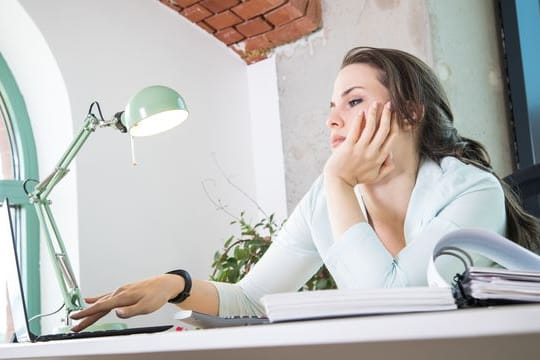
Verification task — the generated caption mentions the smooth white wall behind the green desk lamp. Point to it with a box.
[7,0,268,332]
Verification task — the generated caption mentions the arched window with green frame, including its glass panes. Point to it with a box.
[0,53,41,333]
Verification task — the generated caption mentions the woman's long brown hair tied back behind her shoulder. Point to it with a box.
[341,47,540,253]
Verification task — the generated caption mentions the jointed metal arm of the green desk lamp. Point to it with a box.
[28,114,122,325]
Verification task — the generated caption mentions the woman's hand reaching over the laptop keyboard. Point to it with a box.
[71,274,184,332]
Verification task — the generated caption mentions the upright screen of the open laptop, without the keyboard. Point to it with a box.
[0,198,32,342]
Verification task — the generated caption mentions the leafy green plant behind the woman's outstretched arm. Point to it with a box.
[210,212,336,290]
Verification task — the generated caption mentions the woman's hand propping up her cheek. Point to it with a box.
[324,102,399,187]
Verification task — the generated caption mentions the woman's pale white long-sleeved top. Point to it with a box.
[214,157,506,316]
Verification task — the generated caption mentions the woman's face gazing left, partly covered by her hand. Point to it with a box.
[326,64,390,149]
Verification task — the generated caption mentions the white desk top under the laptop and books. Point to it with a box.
[0,305,540,360]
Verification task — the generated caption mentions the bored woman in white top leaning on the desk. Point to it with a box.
[72,48,540,331]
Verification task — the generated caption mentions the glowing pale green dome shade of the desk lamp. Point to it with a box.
[122,85,188,136]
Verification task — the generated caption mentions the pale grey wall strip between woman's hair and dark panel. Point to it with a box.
[427,0,514,177]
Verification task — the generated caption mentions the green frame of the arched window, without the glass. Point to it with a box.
[0,53,41,334]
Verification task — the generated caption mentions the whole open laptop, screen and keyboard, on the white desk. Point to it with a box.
[0,198,173,342]
